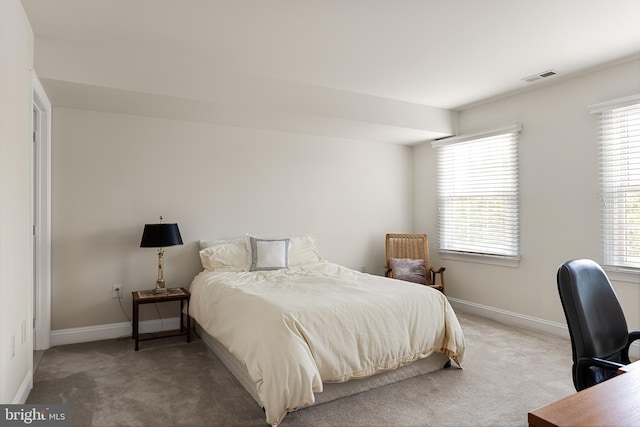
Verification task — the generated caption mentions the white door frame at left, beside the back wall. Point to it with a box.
[31,70,51,350]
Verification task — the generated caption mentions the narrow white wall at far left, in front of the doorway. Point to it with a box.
[0,0,33,403]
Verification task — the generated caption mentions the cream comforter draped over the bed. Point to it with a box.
[189,262,464,425]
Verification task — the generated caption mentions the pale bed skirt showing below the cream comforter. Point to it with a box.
[194,322,449,407]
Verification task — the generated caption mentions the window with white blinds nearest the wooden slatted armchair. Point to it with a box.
[432,125,521,260]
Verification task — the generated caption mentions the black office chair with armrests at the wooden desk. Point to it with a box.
[558,259,640,391]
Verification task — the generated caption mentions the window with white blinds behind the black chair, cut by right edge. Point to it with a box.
[591,96,640,268]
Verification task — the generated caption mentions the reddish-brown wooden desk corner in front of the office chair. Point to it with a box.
[528,365,640,427]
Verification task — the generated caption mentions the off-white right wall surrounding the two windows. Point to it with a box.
[414,59,640,328]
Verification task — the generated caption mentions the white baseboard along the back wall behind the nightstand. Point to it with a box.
[51,317,180,347]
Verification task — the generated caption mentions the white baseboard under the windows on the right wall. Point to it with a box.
[447,297,640,359]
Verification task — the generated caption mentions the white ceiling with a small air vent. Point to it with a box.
[17,0,640,144]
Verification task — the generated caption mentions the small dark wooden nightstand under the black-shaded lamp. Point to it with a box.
[131,288,191,351]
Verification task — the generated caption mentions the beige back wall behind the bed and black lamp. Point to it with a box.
[52,107,413,330]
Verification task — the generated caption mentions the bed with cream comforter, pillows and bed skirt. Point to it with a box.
[189,236,464,426]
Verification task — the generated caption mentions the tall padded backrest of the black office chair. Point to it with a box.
[558,259,629,370]
